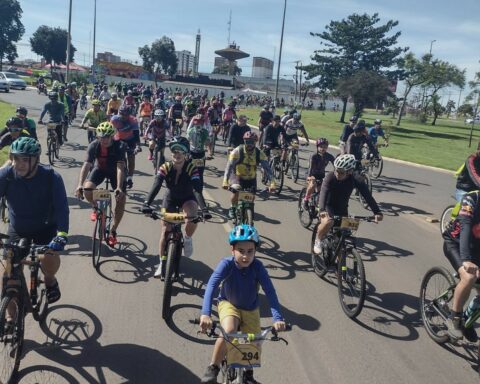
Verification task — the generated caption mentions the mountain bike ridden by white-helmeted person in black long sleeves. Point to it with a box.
[310,216,375,318]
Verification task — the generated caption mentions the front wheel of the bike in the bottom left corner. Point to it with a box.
[0,292,25,384]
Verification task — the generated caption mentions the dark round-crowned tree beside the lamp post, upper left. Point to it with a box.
[30,25,77,73]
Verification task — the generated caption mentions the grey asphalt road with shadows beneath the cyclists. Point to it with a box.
[0,90,478,384]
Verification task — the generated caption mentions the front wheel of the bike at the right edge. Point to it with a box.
[420,267,455,344]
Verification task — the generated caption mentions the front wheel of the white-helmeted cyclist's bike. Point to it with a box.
[337,247,367,319]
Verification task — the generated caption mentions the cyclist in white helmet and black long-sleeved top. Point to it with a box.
[313,154,383,253]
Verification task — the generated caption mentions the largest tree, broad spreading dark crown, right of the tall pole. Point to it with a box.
[303,13,408,122]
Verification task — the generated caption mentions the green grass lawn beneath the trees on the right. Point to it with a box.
[238,108,480,170]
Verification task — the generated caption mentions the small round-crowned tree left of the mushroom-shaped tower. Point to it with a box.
[138,36,178,85]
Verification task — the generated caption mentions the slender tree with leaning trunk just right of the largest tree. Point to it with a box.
[397,52,432,125]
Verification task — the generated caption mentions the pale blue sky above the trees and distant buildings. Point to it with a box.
[14,0,480,98]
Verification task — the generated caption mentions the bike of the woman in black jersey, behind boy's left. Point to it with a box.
[142,209,204,322]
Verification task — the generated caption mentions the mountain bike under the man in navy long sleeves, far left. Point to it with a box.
[0,235,49,383]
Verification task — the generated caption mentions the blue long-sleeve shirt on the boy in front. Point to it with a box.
[202,256,283,322]
